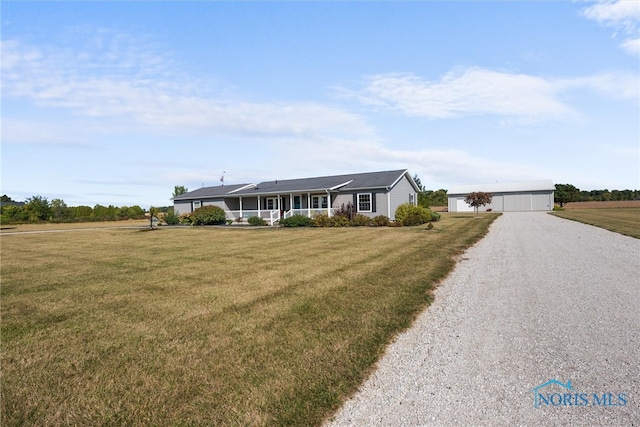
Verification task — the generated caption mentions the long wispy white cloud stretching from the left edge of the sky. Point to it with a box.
[2,38,372,142]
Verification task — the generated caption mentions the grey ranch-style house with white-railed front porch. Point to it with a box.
[173,170,419,225]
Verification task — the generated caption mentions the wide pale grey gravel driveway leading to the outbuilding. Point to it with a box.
[329,213,640,426]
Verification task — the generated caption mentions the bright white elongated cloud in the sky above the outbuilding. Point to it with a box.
[343,68,638,123]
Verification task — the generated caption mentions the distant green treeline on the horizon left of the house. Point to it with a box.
[0,195,168,224]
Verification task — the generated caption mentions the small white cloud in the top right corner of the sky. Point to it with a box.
[581,0,640,55]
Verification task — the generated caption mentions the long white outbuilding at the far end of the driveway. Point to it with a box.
[447,180,556,212]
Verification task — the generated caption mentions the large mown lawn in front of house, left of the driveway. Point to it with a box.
[0,214,496,426]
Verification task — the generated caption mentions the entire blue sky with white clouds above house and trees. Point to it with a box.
[1,0,640,208]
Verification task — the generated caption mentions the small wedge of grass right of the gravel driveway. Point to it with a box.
[552,208,640,239]
